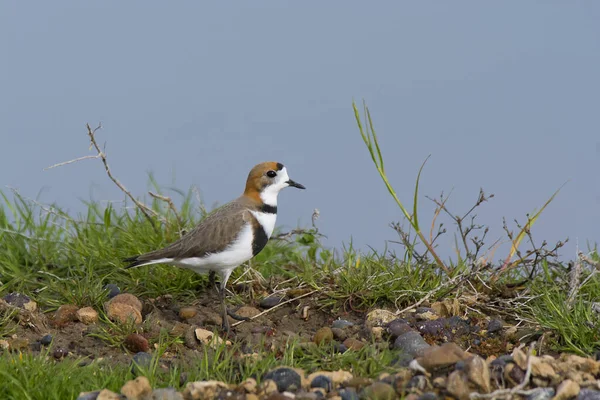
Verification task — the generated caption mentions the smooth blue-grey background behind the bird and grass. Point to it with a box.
[0,0,600,258]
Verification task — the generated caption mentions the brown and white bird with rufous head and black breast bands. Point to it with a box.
[123,161,306,334]
